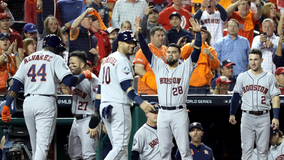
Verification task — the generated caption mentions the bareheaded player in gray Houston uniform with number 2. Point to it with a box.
[229,49,280,160]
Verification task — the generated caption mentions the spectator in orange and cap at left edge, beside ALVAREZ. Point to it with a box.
[0,33,21,94]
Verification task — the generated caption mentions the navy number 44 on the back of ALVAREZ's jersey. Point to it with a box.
[27,63,46,82]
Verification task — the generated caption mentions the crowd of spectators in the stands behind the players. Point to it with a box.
[0,0,284,157]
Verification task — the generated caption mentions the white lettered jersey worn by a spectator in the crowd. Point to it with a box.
[199,10,225,46]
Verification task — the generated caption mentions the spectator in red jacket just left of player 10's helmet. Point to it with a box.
[91,18,111,76]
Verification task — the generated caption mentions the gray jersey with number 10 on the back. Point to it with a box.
[99,51,134,105]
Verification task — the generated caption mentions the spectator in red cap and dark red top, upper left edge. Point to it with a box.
[0,12,23,57]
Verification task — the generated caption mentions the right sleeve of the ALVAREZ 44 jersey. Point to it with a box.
[54,56,72,81]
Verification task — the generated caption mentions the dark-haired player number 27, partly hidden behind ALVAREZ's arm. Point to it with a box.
[68,51,100,160]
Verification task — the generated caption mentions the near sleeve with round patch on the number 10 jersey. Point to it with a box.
[116,61,133,83]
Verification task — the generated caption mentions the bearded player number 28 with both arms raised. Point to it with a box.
[135,17,201,160]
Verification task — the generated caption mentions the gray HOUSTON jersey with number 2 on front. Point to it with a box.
[234,70,281,111]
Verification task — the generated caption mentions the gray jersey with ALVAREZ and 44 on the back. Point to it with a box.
[14,50,72,96]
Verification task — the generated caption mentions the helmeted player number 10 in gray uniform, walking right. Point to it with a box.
[89,30,154,160]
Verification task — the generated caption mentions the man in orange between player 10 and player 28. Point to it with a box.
[133,26,167,95]
